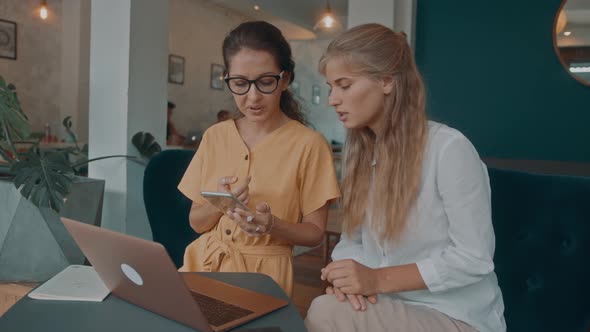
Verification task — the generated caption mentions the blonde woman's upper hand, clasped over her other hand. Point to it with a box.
[321,259,378,296]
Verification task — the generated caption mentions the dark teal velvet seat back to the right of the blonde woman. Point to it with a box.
[489,168,590,332]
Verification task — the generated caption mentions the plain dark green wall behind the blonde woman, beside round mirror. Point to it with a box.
[416,0,590,162]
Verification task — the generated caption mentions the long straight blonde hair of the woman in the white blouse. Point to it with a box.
[319,24,428,241]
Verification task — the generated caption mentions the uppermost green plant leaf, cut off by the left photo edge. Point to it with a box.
[0,76,31,141]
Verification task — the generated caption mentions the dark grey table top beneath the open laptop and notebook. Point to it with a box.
[0,272,305,332]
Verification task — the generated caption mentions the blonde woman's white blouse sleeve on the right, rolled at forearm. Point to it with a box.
[417,136,495,292]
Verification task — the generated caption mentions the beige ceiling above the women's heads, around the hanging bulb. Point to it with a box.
[208,0,348,40]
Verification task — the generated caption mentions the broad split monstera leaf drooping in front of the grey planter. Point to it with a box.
[11,150,73,212]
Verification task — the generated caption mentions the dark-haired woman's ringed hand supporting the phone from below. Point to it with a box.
[228,202,275,236]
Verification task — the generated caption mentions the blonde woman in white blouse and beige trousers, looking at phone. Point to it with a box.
[306,24,506,332]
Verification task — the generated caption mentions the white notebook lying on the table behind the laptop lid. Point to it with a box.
[28,265,110,302]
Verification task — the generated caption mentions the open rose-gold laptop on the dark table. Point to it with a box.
[61,218,288,331]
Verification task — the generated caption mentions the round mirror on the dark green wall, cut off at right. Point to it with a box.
[553,0,590,86]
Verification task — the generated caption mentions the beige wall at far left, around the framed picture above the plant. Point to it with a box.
[0,0,62,136]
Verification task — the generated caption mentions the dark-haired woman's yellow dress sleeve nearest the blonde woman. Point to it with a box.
[299,134,340,216]
